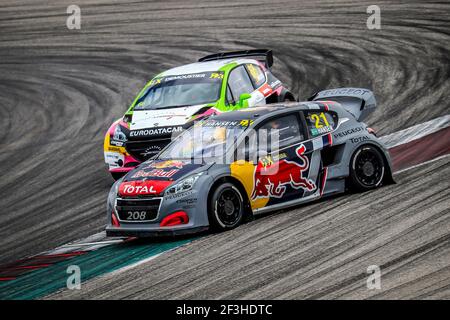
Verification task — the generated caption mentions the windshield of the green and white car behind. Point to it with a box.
[134,72,223,110]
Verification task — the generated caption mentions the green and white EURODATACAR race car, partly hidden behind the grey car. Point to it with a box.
[104,50,295,179]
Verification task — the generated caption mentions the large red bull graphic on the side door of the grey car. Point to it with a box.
[252,145,316,200]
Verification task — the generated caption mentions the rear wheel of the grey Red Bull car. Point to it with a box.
[349,145,386,192]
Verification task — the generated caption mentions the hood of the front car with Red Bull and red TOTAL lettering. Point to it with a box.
[119,160,204,197]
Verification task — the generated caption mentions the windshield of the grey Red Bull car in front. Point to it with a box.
[158,120,248,161]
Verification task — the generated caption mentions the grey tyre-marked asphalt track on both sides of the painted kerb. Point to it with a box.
[0,0,450,298]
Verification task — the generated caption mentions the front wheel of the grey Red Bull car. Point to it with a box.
[208,182,244,231]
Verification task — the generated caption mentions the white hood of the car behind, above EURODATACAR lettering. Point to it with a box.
[130,104,206,130]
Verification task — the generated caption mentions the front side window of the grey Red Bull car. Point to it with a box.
[258,114,305,150]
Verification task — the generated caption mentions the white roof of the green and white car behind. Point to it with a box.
[159,58,256,77]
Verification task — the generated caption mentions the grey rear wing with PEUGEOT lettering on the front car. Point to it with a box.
[308,88,377,120]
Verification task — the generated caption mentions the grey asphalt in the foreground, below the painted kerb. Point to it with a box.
[48,157,450,300]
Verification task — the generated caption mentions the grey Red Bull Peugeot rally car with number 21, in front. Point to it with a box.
[106,88,393,237]
